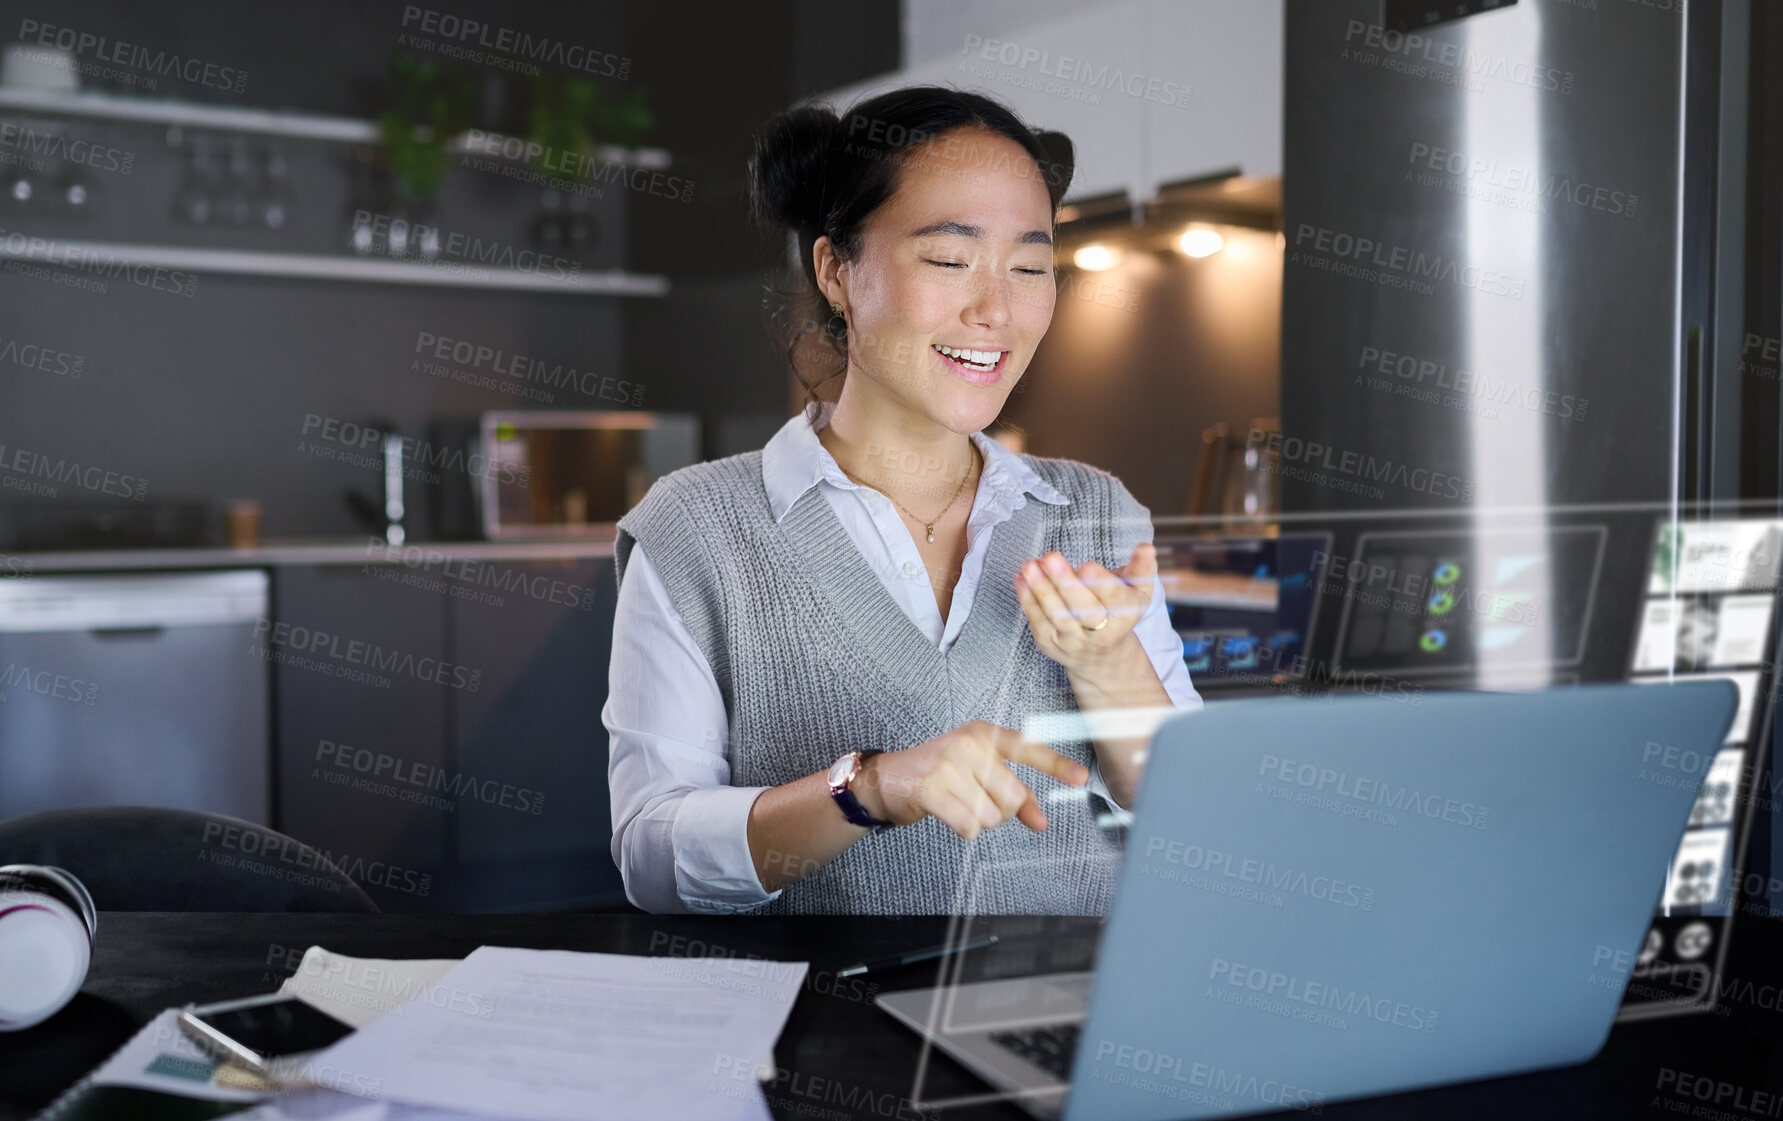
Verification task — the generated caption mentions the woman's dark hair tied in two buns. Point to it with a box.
[749,86,1075,415]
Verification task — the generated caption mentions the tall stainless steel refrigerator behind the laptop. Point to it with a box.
[1283,0,1778,1014]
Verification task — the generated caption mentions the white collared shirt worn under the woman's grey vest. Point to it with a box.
[601,403,1202,914]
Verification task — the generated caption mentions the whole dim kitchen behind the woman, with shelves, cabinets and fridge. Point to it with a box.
[0,0,1783,1005]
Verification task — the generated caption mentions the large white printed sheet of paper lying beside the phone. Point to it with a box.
[316,946,809,1121]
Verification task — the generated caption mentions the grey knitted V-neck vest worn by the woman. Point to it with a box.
[613,441,1152,914]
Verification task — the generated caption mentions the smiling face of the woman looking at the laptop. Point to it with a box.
[818,128,1057,433]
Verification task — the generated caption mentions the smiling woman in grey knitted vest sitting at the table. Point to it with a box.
[603,87,1200,914]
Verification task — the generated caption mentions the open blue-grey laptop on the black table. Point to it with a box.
[877,681,1737,1121]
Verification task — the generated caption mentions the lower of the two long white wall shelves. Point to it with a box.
[0,239,669,296]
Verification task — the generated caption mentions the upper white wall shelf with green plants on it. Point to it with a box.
[0,87,670,171]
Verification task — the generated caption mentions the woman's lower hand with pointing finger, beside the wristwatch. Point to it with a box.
[852,720,1089,841]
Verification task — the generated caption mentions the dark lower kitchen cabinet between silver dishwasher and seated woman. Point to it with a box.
[273,558,624,912]
